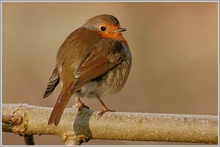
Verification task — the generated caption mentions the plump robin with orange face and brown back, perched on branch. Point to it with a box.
[43,14,132,126]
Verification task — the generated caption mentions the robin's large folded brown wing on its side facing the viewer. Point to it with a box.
[70,48,121,93]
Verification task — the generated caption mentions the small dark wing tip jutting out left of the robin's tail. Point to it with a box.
[43,66,59,98]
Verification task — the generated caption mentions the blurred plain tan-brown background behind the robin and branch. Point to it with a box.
[2,2,218,145]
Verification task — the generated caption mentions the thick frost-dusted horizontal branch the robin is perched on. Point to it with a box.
[2,104,218,145]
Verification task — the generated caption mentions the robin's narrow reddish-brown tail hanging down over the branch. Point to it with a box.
[48,90,71,125]
